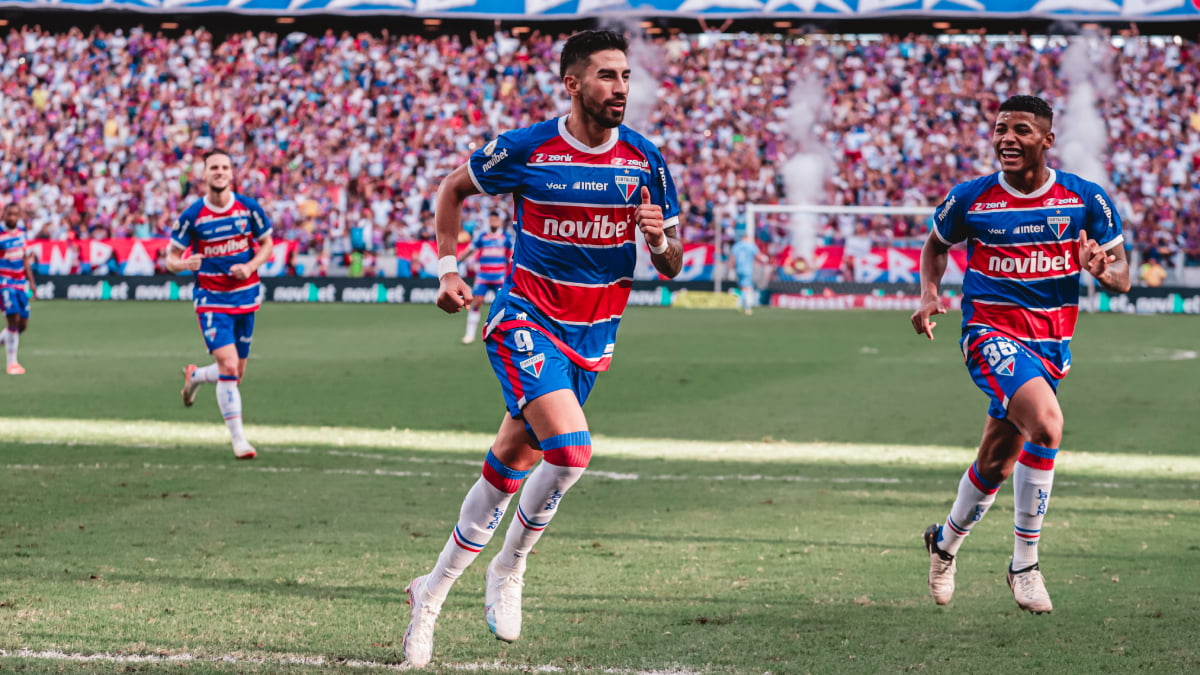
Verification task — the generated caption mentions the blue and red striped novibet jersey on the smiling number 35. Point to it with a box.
[934,171,1124,378]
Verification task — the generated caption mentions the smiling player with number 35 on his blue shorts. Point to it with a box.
[912,96,1129,614]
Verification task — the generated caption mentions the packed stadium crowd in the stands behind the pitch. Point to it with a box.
[0,26,1200,276]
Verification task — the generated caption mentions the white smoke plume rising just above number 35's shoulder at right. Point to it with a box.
[1055,30,1116,187]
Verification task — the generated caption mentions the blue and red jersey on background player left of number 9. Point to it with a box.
[170,193,271,313]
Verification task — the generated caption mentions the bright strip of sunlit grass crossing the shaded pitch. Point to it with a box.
[0,418,1200,480]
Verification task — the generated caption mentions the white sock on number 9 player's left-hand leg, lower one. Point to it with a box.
[425,477,512,604]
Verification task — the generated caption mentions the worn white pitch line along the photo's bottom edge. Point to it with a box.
[0,649,700,675]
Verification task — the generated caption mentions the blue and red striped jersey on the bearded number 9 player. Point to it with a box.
[468,117,679,371]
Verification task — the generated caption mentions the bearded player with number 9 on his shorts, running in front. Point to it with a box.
[404,30,683,667]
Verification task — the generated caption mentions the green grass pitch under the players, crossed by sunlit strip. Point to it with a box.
[0,300,1200,675]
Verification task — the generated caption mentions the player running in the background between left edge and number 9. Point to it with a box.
[167,149,271,459]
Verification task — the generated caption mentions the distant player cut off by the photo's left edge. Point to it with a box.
[0,203,37,375]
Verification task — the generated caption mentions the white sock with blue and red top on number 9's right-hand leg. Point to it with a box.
[494,431,592,571]
